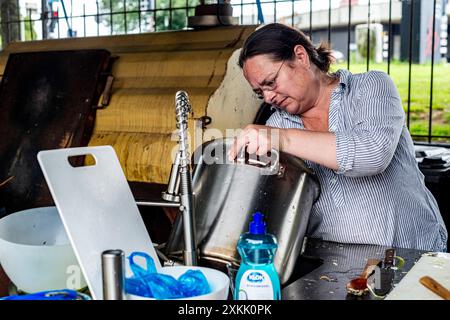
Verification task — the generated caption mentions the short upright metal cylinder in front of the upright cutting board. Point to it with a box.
[102,249,125,300]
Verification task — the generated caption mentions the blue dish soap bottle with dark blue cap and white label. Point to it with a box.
[234,212,281,300]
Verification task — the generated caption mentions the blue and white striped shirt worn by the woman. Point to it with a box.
[266,70,448,251]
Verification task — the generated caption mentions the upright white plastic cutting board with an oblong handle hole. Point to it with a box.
[37,146,161,299]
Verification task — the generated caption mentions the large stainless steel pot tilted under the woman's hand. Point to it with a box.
[166,139,320,284]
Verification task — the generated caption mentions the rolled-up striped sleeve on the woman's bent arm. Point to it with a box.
[335,72,405,177]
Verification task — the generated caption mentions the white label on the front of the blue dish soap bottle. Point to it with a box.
[238,269,274,300]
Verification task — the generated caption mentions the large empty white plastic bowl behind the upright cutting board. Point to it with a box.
[0,207,86,293]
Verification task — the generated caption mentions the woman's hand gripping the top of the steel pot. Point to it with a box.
[228,124,283,161]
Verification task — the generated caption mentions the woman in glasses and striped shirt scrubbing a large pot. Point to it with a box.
[229,24,447,251]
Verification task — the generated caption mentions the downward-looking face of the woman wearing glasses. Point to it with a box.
[243,47,320,114]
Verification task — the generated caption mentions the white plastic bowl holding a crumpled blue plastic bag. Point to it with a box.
[127,266,230,300]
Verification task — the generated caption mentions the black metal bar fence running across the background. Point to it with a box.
[1,0,450,144]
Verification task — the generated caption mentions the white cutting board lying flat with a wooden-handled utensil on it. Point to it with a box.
[386,252,450,300]
